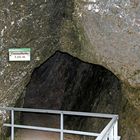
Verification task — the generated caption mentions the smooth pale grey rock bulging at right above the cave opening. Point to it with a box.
[77,0,140,88]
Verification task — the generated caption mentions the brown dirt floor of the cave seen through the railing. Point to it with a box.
[15,113,80,140]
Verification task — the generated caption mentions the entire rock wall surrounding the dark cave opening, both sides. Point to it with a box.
[0,0,140,140]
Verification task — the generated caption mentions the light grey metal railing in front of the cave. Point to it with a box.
[0,107,120,140]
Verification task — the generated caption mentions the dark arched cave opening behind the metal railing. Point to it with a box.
[15,52,121,140]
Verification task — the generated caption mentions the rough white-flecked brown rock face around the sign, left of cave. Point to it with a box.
[0,0,74,106]
